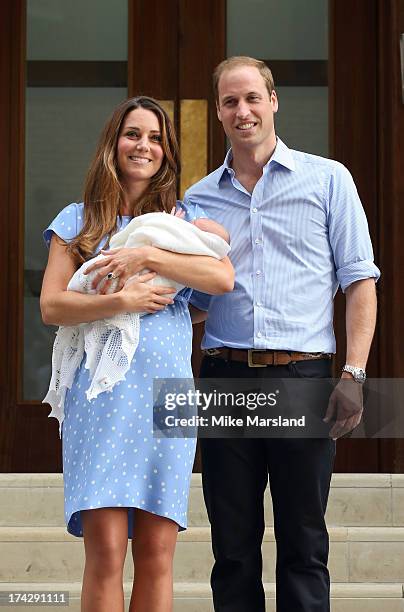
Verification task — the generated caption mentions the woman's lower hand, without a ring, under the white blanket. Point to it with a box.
[119,272,176,313]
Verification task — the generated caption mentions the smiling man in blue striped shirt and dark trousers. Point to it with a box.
[185,57,379,612]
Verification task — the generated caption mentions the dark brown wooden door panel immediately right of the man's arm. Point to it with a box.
[330,0,380,472]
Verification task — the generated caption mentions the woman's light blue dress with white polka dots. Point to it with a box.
[44,204,205,538]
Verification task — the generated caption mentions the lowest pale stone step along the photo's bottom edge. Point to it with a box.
[0,582,404,612]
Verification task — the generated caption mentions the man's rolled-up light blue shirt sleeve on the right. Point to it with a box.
[328,164,380,293]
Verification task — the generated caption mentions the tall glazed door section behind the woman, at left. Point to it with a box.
[23,0,127,400]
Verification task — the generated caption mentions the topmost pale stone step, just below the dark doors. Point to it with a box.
[0,474,404,527]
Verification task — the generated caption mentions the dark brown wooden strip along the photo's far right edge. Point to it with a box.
[377,0,404,472]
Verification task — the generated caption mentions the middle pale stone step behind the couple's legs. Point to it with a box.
[0,527,404,583]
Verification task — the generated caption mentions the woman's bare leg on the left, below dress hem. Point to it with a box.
[81,508,128,612]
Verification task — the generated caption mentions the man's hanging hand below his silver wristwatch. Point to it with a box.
[323,374,363,440]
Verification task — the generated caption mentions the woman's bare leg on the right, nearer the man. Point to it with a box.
[129,510,178,612]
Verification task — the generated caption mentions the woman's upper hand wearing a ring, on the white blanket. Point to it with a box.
[84,246,153,294]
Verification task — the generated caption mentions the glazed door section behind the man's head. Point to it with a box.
[227,0,328,156]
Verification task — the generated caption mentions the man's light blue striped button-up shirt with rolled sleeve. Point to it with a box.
[184,138,380,353]
